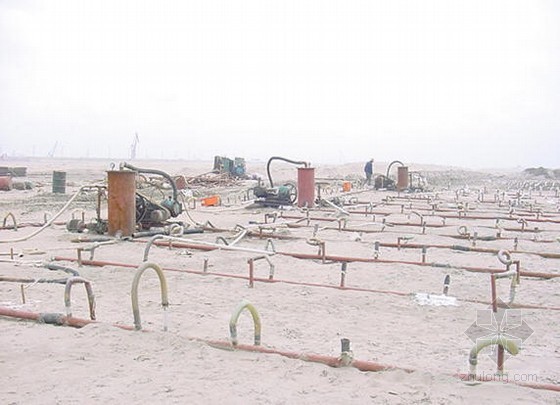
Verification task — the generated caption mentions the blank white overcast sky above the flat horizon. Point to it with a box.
[0,0,560,168]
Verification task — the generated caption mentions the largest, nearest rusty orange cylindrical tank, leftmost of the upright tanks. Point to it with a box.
[107,170,136,236]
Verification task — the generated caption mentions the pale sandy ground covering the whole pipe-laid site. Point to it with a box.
[0,159,560,404]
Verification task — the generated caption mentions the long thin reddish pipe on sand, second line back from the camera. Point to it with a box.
[53,257,560,311]
